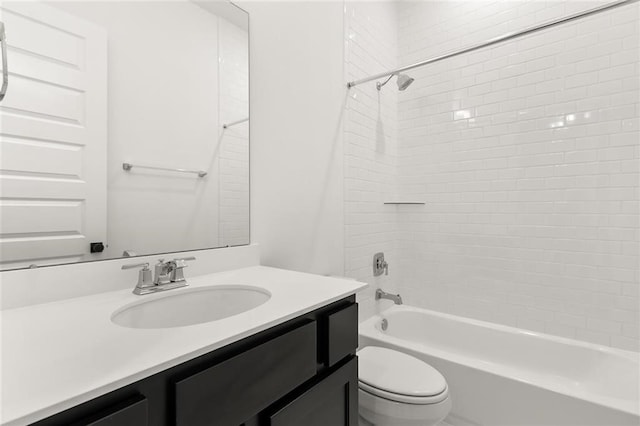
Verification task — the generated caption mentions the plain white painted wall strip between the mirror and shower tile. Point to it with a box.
[240,2,346,275]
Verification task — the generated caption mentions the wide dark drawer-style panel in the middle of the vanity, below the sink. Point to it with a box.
[175,320,317,426]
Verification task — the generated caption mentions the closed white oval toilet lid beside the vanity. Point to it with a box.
[358,346,447,396]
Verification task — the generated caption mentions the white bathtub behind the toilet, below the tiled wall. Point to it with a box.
[360,306,640,426]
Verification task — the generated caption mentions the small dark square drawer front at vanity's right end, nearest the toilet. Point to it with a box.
[325,303,358,366]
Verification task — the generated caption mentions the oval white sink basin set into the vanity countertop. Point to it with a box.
[111,285,271,328]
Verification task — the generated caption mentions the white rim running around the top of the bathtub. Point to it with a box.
[359,305,640,416]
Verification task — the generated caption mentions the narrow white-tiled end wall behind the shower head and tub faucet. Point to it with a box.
[344,2,399,319]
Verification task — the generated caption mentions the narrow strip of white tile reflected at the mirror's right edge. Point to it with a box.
[218,19,249,246]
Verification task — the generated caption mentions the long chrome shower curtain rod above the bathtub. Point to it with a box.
[347,0,640,89]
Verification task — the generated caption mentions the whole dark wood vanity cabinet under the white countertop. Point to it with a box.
[35,296,358,426]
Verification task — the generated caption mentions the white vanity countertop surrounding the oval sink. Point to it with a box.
[0,266,366,425]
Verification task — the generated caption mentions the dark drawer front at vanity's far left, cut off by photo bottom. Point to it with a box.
[67,395,148,426]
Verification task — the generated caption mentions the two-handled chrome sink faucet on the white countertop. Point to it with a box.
[122,256,196,295]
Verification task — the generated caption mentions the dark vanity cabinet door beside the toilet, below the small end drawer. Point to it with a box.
[268,357,358,426]
